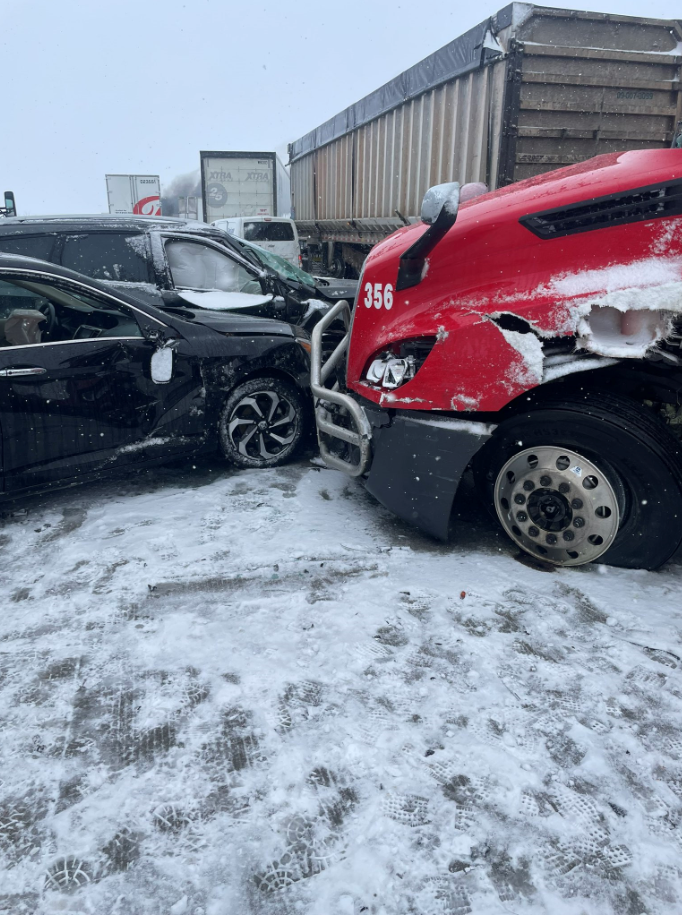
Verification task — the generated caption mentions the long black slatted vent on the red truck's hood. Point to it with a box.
[519,181,682,239]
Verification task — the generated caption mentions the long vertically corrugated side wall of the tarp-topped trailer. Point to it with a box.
[291,62,505,220]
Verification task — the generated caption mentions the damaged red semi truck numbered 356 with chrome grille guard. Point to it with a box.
[312,149,682,569]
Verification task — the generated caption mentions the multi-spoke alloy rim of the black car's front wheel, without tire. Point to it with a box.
[227,390,298,460]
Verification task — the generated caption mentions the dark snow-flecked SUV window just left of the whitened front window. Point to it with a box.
[62,232,149,283]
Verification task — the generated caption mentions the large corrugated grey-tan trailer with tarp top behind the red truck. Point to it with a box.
[289,3,682,276]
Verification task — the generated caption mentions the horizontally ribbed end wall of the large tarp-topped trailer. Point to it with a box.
[500,9,682,183]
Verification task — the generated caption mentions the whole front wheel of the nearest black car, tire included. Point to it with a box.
[218,377,305,467]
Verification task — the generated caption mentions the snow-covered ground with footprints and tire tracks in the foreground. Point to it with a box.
[0,452,682,915]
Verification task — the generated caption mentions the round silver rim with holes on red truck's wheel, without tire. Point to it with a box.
[494,446,620,566]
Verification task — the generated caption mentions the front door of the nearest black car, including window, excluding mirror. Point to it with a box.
[0,270,205,492]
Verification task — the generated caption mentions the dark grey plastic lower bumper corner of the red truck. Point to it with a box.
[365,416,495,540]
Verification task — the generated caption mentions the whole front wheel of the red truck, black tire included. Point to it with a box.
[474,392,682,569]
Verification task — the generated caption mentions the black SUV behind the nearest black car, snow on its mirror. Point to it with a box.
[0,215,338,329]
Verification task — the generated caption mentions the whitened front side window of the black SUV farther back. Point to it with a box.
[166,239,261,294]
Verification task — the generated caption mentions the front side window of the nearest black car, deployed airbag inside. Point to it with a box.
[0,280,142,348]
